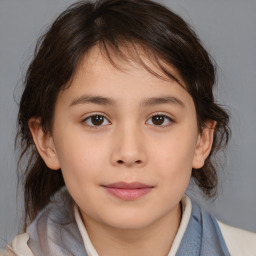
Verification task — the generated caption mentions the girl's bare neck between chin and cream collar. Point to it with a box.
[83,202,182,256]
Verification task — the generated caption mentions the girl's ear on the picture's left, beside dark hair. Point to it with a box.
[28,118,60,170]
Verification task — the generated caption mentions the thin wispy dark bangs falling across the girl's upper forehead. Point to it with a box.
[88,37,186,85]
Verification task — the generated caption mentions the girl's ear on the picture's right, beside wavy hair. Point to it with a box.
[192,120,216,169]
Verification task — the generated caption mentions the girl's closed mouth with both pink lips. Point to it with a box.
[102,182,154,201]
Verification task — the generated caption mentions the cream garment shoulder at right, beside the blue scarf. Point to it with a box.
[217,220,256,256]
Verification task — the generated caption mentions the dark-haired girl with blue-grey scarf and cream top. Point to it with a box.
[2,0,256,256]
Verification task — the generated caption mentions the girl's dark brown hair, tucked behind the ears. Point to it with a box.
[17,0,230,227]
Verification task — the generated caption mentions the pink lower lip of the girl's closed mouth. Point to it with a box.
[104,187,153,201]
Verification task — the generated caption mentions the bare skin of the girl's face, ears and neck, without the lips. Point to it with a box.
[29,48,215,256]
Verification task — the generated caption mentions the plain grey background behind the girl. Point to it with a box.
[0,0,256,247]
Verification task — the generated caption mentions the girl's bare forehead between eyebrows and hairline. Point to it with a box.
[58,47,192,110]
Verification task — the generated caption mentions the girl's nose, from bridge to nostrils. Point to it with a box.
[111,124,147,168]
